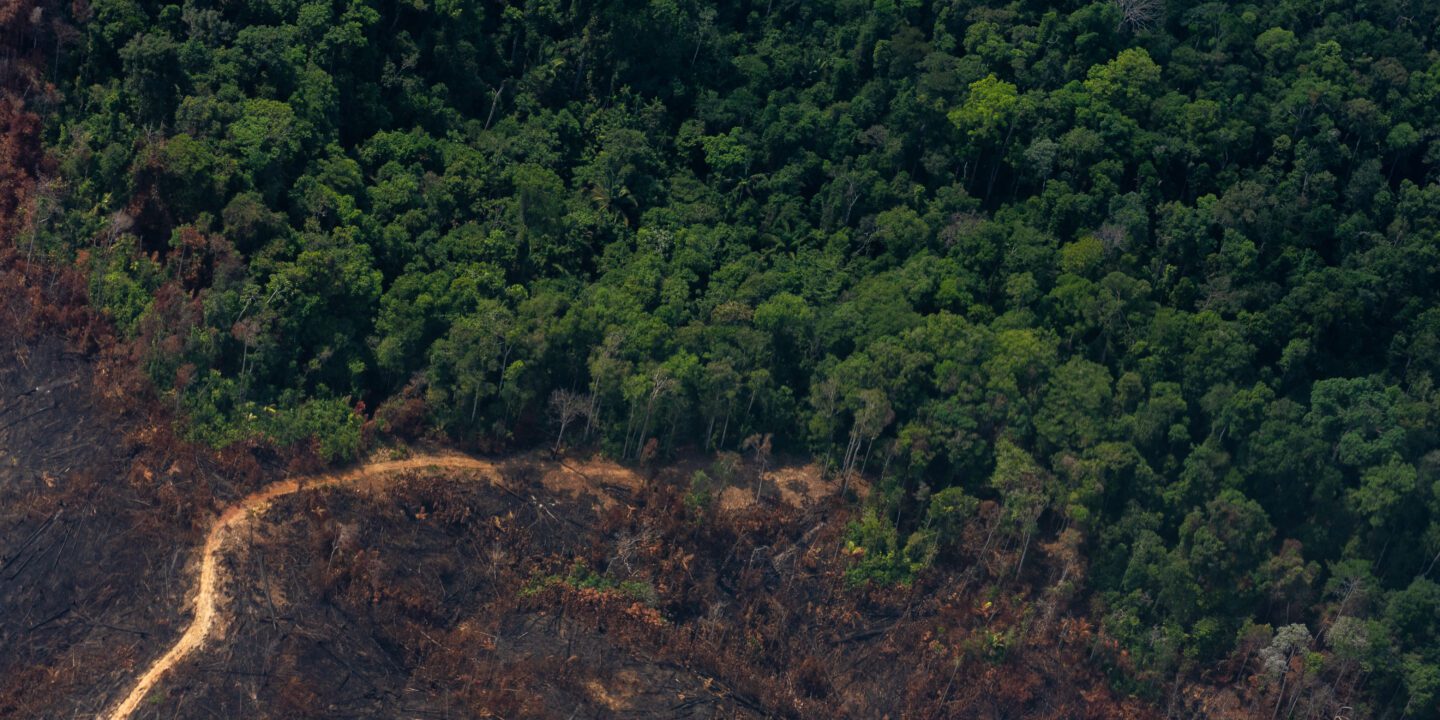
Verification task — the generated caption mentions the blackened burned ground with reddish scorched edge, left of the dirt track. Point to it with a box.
[0,256,266,719]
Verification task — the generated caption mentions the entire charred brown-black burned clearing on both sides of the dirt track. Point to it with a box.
[0,264,1155,719]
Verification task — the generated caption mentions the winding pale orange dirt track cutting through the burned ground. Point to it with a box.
[104,454,500,720]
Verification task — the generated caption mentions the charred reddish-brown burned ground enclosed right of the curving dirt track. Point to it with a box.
[90,458,1146,719]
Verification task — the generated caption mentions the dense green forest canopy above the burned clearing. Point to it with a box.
[16,0,1440,719]
